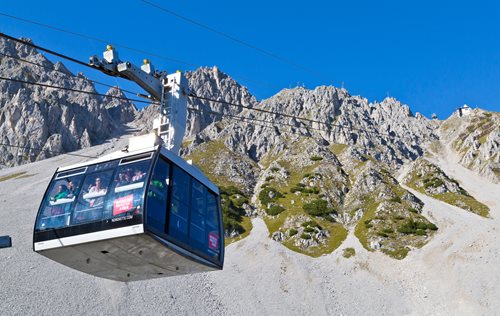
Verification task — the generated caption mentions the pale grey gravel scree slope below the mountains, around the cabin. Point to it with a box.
[0,141,500,315]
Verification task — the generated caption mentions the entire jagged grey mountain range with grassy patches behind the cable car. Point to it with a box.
[0,35,500,259]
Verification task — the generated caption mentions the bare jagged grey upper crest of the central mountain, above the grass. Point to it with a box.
[191,82,437,166]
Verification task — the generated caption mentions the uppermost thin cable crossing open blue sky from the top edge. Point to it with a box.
[140,0,324,76]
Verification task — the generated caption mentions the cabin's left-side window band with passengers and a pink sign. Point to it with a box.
[35,155,151,230]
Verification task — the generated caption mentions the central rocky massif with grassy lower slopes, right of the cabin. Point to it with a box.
[185,87,438,258]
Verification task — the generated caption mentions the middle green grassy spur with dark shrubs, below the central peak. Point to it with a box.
[257,156,347,257]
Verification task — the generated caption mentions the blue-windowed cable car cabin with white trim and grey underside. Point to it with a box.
[33,134,224,281]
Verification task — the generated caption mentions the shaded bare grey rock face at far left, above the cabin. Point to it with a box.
[0,38,119,166]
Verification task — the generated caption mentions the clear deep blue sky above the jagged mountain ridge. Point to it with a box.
[0,0,500,118]
